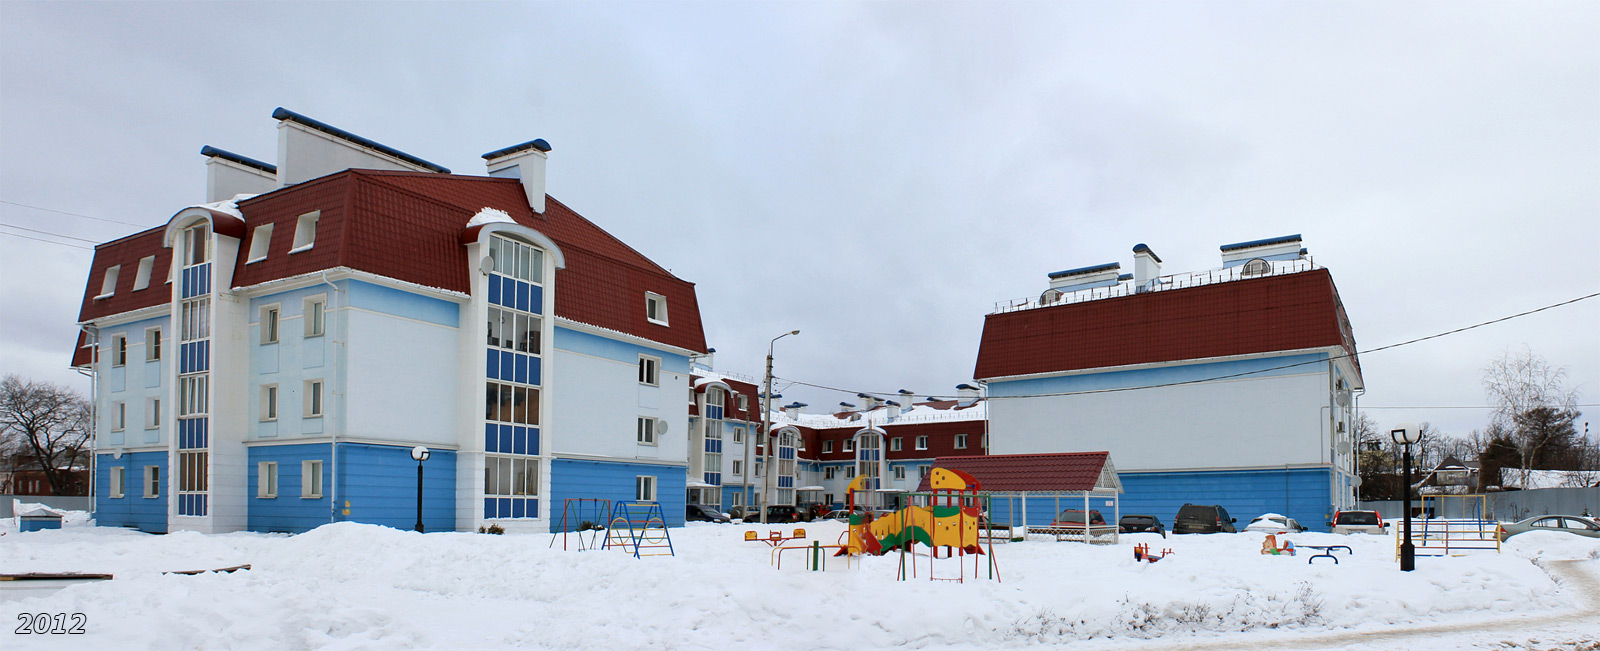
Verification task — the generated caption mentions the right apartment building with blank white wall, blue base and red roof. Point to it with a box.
[974,235,1363,526]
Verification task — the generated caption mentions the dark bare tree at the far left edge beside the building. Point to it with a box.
[0,374,93,494]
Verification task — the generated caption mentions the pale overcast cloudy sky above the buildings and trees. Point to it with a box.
[0,2,1600,433]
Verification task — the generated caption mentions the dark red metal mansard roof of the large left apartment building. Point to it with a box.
[80,170,706,352]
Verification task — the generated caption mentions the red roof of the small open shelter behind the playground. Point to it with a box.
[917,453,1110,493]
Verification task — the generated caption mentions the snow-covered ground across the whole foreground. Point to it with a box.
[0,523,1600,649]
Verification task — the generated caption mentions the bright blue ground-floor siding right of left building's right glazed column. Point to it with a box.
[550,459,688,531]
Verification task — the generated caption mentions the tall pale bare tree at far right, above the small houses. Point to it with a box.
[1483,347,1578,485]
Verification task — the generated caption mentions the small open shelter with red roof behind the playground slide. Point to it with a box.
[917,453,1123,542]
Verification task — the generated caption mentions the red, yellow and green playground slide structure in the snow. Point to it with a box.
[834,469,998,582]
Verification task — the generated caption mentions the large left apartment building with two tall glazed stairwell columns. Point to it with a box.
[74,109,706,533]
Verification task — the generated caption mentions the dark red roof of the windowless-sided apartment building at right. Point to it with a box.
[973,269,1355,379]
